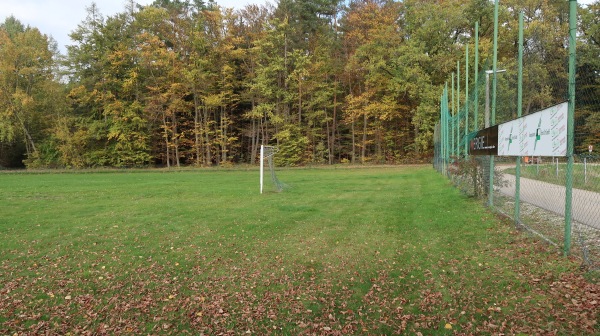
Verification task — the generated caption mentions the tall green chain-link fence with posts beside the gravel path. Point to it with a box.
[434,2,600,269]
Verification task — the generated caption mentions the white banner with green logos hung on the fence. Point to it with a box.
[498,102,568,156]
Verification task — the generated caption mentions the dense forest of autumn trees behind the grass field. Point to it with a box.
[0,0,600,168]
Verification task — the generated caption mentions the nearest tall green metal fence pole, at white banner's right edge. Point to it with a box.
[565,0,577,255]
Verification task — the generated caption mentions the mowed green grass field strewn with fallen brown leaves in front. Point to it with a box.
[0,166,600,335]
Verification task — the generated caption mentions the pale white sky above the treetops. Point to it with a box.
[0,0,271,53]
